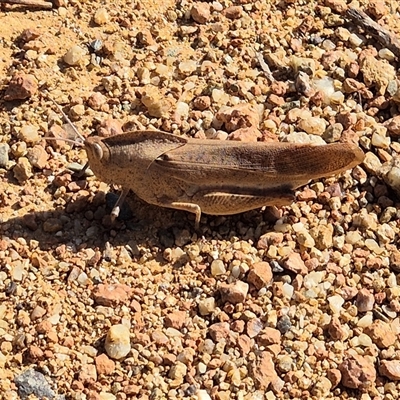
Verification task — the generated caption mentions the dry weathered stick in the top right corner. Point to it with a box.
[346,7,400,58]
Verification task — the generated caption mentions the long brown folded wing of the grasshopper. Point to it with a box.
[155,139,364,189]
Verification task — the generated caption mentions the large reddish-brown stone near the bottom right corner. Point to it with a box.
[339,354,376,389]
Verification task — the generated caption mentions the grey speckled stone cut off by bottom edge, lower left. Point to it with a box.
[14,369,56,399]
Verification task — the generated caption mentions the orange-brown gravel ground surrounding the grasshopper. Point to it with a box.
[0,0,400,400]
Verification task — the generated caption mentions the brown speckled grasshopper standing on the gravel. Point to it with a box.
[47,98,364,227]
